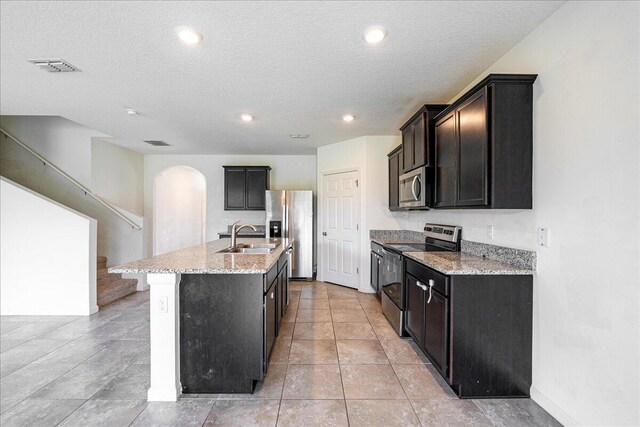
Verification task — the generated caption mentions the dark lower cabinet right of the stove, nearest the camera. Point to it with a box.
[404,258,533,398]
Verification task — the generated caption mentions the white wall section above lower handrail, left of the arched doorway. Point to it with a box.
[91,138,144,215]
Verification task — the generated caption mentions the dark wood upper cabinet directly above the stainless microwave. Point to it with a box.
[400,104,447,172]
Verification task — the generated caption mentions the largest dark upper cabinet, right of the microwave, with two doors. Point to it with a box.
[434,74,536,209]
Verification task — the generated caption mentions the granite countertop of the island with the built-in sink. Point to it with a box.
[109,238,293,274]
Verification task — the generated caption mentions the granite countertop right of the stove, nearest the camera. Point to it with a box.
[403,252,535,275]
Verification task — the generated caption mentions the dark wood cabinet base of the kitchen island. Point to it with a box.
[180,254,289,393]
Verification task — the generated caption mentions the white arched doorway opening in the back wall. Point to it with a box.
[153,166,207,255]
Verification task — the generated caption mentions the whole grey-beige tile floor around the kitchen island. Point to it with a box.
[0,282,559,427]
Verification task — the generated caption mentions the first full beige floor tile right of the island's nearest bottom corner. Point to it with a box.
[282,365,344,399]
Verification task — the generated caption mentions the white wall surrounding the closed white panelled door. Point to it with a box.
[316,136,401,292]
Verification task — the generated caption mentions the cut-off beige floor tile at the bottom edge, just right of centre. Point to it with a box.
[347,400,420,427]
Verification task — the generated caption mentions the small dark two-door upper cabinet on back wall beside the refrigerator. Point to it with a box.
[223,166,271,211]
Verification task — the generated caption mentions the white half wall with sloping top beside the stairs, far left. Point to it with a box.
[0,178,98,315]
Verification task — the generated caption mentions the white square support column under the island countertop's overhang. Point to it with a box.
[147,274,182,402]
